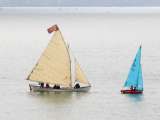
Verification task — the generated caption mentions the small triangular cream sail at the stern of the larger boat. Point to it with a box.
[75,60,90,85]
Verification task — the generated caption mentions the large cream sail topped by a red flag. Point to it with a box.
[28,25,72,87]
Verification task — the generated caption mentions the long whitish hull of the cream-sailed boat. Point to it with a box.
[29,84,91,92]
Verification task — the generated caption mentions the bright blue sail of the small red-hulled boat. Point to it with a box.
[124,46,143,90]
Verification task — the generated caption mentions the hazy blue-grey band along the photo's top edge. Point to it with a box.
[0,0,160,7]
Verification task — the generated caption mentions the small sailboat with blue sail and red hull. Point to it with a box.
[121,46,143,94]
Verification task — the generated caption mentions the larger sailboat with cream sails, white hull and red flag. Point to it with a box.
[27,25,91,92]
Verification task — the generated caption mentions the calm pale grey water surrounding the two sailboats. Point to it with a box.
[0,8,160,120]
